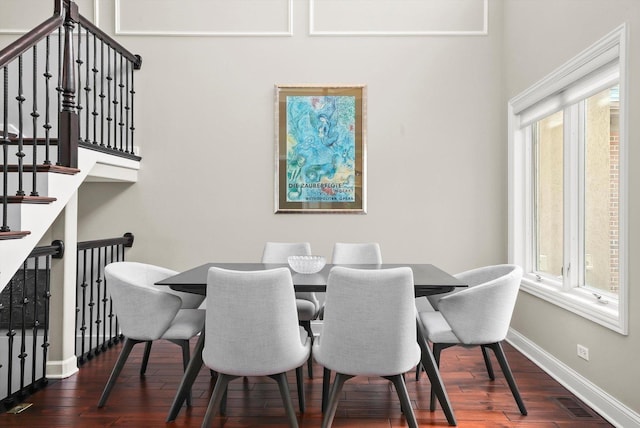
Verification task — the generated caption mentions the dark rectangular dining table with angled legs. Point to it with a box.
[155,262,467,425]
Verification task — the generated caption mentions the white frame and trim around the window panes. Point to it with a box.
[508,24,629,335]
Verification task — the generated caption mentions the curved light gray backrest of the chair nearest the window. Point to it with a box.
[438,264,522,345]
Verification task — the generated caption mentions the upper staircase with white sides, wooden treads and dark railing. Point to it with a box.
[0,0,141,291]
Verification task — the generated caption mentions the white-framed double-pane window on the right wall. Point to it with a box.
[509,26,628,334]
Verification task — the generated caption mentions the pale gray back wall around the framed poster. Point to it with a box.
[75,0,507,271]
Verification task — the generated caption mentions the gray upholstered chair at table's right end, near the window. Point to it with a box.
[418,264,527,415]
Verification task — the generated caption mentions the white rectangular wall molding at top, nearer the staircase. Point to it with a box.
[115,0,293,37]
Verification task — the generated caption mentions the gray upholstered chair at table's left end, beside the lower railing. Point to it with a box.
[98,262,205,407]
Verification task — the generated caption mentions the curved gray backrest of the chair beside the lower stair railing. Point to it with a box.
[104,262,182,340]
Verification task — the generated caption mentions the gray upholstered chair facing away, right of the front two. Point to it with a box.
[313,266,420,427]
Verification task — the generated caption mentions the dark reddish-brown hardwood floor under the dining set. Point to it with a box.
[0,342,611,428]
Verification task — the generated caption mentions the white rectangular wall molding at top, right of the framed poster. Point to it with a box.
[309,0,489,36]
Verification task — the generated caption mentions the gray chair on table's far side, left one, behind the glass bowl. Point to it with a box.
[262,241,320,379]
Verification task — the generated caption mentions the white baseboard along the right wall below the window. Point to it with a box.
[507,329,640,428]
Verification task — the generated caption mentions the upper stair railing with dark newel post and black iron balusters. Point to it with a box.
[0,0,142,239]
